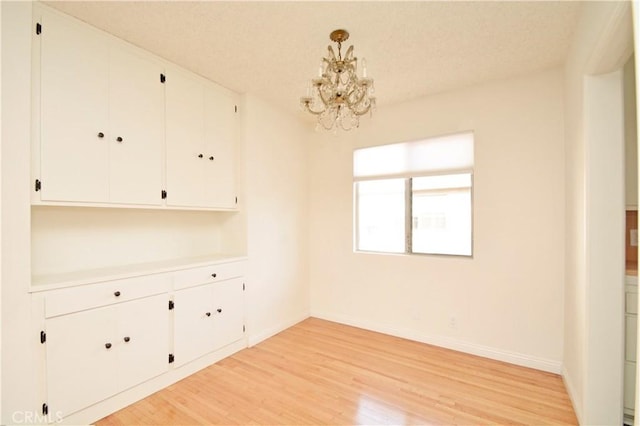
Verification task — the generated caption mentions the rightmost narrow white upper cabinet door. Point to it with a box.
[204,85,238,209]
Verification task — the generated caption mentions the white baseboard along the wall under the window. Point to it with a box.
[311,311,561,374]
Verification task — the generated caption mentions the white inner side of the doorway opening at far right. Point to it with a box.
[583,70,625,424]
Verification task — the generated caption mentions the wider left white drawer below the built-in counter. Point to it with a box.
[45,274,171,318]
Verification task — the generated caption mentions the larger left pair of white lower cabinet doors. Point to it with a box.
[45,294,169,415]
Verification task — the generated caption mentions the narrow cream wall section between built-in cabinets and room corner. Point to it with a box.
[242,96,310,344]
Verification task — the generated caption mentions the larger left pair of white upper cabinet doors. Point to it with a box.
[37,8,164,205]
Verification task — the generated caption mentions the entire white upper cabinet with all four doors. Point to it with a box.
[33,7,239,209]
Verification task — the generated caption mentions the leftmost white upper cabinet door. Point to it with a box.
[39,14,110,202]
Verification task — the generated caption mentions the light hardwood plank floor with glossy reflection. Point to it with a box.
[97,318,577,426]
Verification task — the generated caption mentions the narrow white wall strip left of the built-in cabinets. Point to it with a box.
[0,2,36,424]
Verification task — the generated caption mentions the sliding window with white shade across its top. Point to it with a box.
[353,133,473,256]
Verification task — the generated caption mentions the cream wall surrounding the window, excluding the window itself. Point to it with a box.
[310,70,564,372]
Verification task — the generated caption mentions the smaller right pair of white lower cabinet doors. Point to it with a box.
[174,278,244,365]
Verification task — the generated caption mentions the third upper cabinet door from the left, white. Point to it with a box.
[165,68,208,207]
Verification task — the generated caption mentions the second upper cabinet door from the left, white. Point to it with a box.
[108,48,164,205]
